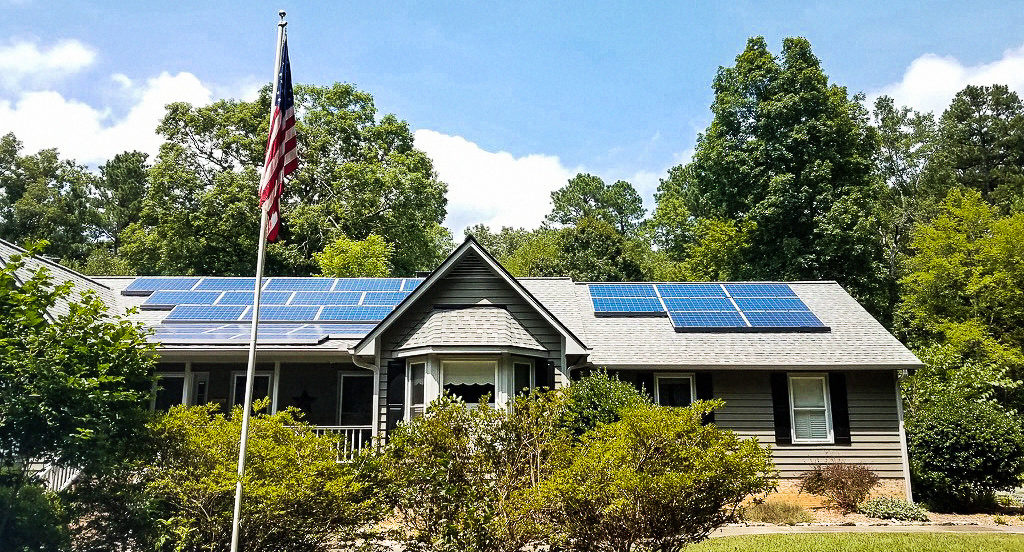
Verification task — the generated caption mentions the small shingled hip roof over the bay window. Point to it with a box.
[397,305,545,351]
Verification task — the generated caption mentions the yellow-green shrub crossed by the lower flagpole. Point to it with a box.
[90,399,378,552]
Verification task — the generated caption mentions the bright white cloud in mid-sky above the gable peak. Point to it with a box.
[416,129,583,239]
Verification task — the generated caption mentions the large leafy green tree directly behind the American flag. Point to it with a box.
[125,84,451,274]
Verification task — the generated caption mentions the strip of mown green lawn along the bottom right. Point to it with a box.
[686,533,1024,552]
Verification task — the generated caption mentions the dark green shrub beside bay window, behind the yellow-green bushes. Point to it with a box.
[560,371,650,436]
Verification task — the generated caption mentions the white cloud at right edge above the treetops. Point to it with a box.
[868,46,1024,116]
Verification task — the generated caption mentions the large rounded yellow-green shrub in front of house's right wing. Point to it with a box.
[538,401,775,551]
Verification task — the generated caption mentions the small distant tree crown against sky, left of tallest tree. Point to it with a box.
[547,173,644,235]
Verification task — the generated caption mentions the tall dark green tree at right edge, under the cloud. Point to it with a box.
[928,85,1024,213]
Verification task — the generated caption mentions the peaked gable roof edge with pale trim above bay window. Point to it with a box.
[352,236,587,354]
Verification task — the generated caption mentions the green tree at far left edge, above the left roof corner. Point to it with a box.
[0,134,99,261]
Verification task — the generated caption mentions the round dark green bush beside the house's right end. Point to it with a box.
[906,399,1024,511]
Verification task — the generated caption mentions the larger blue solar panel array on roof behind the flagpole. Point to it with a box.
[122,277,423,344]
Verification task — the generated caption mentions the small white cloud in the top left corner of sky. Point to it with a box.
[0,40,96,89]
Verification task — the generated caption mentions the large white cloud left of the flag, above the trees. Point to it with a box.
[0,72,213,164]
